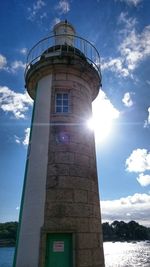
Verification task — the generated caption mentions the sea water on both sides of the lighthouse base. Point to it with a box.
[0,241,150,267]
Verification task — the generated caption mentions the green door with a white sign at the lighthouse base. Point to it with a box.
[45,233,73,267]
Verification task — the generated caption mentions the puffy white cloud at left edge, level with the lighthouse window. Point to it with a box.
[0,86,33,119]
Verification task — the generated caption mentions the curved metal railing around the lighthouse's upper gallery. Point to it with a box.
[25,34,101,76]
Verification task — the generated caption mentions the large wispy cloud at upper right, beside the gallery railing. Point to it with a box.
[102,12,150,77]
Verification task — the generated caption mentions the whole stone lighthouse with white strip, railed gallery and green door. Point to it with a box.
[14,21,104,267]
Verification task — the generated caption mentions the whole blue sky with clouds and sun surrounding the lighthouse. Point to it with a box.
[0,0,150,225]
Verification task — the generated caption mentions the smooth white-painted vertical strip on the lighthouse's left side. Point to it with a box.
[16,75,52,267]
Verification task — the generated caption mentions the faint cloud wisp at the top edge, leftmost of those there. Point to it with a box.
[28,0,46,21]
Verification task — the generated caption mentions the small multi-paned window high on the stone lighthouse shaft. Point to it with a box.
[55,93,69,113]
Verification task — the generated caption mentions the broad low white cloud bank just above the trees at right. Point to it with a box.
[101,193,150,226]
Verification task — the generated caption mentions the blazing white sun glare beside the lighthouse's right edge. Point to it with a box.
[87,90,119,143]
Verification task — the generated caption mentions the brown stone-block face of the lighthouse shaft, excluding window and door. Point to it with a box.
[42,61,104,267]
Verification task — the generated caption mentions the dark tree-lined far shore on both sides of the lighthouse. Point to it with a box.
[0,221,150,247]
